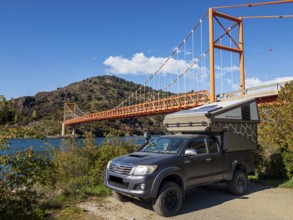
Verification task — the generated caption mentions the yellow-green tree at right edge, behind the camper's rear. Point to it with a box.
[258,81,293,178]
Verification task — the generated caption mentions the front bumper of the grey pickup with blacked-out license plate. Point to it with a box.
[104,169,155,199]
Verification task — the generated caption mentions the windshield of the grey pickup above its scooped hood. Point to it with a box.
[140,137,186,154]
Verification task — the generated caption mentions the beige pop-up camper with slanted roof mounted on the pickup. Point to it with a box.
[164,99,259,151]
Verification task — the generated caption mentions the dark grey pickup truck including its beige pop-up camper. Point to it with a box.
[105,99,259,217]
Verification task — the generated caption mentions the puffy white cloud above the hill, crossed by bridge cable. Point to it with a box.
[103,53,190,75]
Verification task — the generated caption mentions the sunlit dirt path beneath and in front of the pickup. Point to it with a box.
[78,184,293,220]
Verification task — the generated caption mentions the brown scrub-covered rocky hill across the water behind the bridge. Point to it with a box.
[8,75,167,136]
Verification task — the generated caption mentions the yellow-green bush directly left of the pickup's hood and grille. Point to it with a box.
[53,133,136,198]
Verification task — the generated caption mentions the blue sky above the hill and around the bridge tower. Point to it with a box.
[0,0,293,98]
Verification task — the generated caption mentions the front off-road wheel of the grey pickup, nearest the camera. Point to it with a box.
[152,181,183,217]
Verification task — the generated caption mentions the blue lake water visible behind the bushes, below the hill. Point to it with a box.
[5,136,151,154]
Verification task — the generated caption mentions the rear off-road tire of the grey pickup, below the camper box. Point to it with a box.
[228,170,248,195]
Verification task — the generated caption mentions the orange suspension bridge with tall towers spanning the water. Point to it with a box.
[62,1,293,135]
